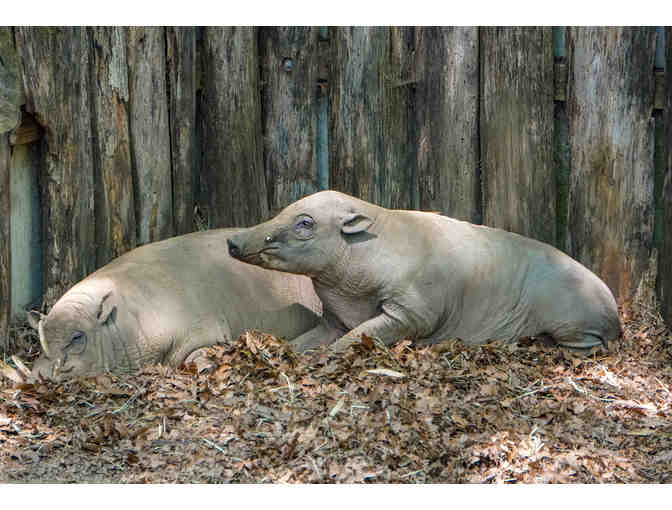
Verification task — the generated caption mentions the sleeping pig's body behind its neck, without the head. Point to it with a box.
[84,229,321,338]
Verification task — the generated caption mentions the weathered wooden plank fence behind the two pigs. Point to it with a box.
[0,27,672,344]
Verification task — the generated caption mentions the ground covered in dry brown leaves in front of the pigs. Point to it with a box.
[0,304,672,483]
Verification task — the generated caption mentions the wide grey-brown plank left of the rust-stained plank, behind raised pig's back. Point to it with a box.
[480,27,556,244]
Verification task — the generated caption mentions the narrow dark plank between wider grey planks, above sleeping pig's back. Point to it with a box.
[166,27,200,235]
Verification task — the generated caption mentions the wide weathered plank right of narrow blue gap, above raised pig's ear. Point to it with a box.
[329,27,415,208]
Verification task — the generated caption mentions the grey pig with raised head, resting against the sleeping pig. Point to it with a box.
[229,191,620,351]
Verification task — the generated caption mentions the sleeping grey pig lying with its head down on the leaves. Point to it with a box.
[29,229,321,380]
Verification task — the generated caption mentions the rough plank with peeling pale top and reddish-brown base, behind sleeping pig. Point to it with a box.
[91,27,136,267]
